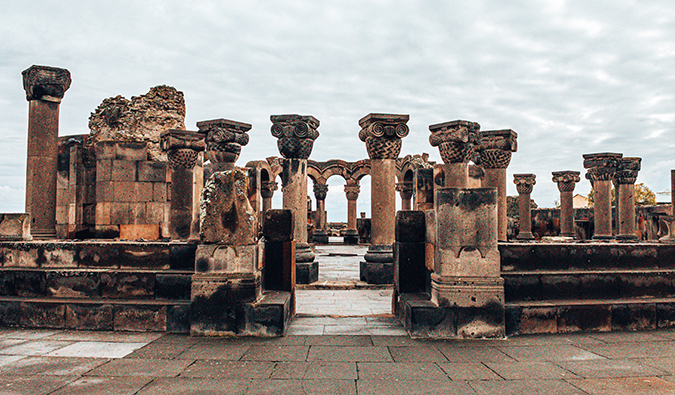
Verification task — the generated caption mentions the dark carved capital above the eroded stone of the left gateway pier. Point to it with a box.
[197,118,251,163]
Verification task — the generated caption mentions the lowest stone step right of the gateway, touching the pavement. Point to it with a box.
[505,298,675,336]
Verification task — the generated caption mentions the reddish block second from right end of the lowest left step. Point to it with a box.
[113,305,167,332]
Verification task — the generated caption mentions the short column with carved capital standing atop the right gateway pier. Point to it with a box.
[429,121,480,188]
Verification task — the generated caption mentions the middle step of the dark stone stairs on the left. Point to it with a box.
[0,267,193,301]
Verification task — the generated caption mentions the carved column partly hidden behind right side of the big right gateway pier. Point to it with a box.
[478,129,518,241]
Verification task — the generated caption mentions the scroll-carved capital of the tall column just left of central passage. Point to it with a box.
[270,114,319,159]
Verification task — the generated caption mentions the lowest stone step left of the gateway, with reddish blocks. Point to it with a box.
[0,296,190,333]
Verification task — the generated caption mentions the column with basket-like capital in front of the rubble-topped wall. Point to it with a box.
[160,129,206,240]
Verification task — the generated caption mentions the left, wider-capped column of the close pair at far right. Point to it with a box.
[583,152,623,240]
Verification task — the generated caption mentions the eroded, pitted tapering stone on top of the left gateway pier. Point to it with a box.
[200,169,258,245]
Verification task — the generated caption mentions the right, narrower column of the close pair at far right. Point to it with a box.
[614,157,642,240]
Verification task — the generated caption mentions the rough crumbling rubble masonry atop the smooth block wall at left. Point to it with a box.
[89,85,185,161]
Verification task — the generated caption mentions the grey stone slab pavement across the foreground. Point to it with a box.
[0,329,675,395]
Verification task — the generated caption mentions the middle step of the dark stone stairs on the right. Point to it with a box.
[502,269,675,302]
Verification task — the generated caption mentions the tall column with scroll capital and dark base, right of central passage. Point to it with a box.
[359,113,410,284]
